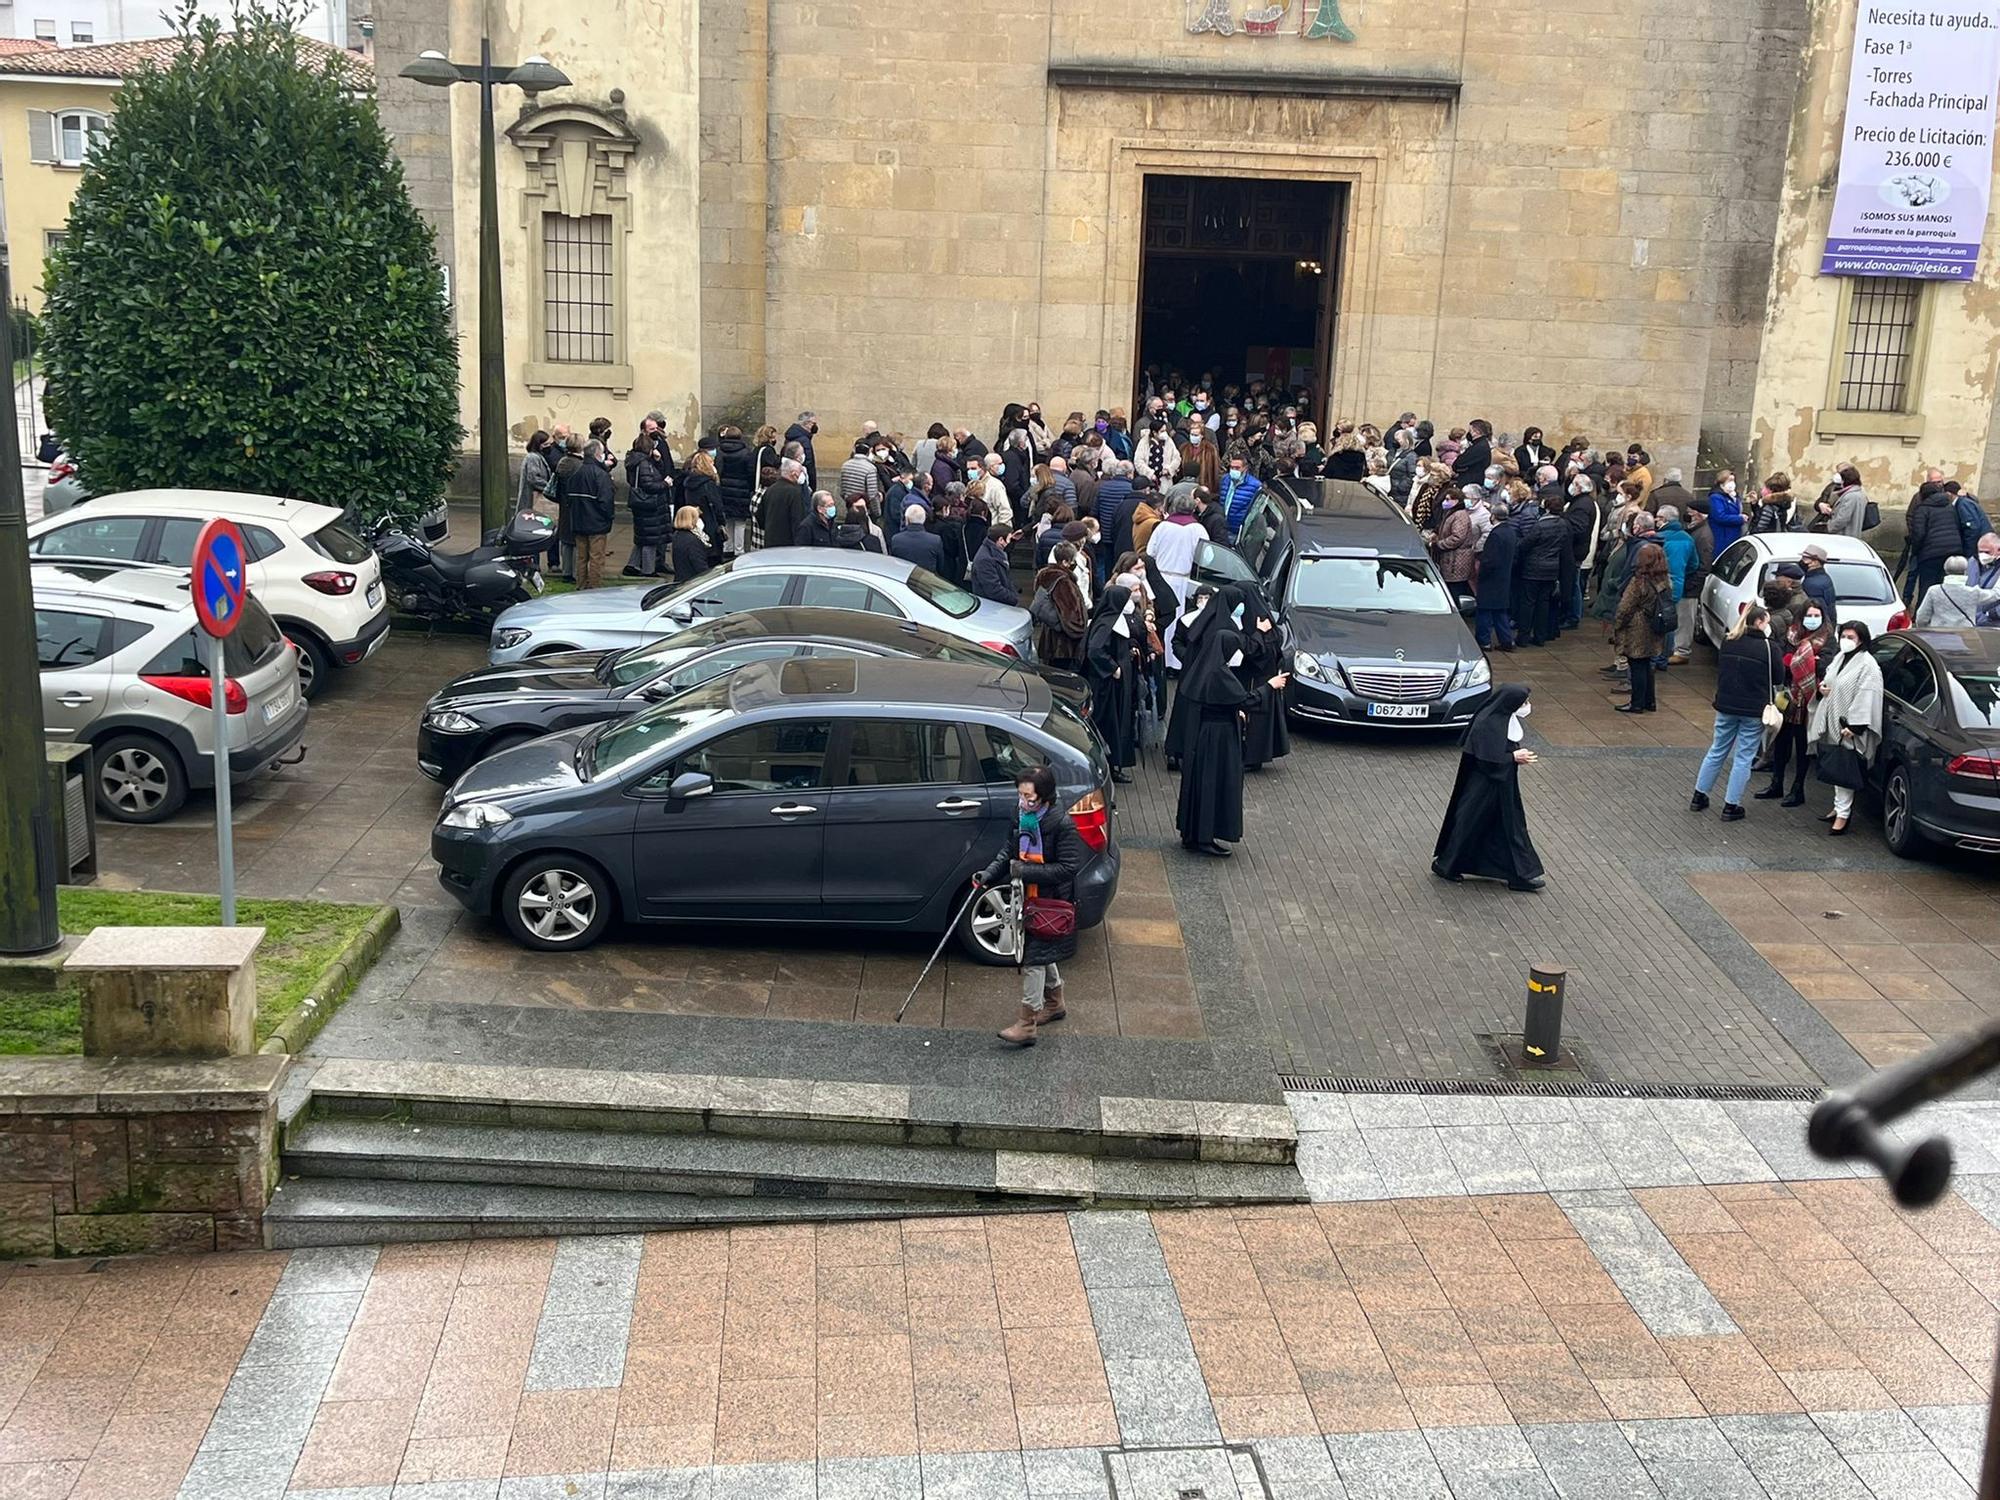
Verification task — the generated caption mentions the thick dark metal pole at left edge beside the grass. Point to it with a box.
[0,266,62,954]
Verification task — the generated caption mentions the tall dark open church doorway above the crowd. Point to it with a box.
[1136,172,1346,416]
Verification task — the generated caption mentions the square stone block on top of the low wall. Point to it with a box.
[62,928,264,1058]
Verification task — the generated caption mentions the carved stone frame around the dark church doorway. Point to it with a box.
[1102,137,1392,430]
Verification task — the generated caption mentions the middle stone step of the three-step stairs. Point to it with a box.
[284,1116,1306,1208]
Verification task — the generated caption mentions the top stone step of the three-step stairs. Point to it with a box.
[296,1058,1298,1164]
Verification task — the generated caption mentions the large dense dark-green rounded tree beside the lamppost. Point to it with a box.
[42,0,462,516]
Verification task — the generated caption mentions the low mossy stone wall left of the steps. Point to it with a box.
[0,1056,286,1256]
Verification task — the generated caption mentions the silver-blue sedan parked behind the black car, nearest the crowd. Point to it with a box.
[490,546,1034,666]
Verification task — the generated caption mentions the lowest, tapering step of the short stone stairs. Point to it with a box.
[264,1178,980,1250]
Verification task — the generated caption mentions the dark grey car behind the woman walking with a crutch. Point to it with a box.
[430,656,1118,964]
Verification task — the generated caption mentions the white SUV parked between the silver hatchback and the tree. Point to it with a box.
[28,490,388,698]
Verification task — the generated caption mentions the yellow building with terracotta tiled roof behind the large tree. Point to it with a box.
[0,38,374,312]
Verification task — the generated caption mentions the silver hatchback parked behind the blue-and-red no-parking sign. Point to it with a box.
[34,564,306,822]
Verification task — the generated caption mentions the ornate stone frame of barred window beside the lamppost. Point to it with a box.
[506,104,638,396]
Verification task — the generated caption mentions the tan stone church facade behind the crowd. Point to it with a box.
[374,0,2000,510]
